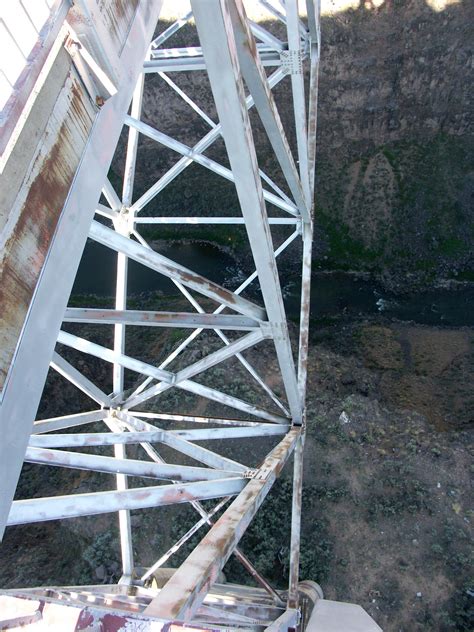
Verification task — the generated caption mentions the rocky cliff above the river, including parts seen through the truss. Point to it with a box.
[114,0,474,290]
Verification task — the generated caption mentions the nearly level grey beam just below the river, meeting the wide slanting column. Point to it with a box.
[64,307,260,331]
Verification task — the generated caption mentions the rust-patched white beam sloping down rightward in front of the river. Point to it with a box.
[89,221,266,320]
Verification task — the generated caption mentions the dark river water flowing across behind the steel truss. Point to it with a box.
[73,242,474,326]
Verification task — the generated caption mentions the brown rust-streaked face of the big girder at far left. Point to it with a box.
[0,74,93,389]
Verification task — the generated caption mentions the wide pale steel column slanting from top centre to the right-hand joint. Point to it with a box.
[192,0,302,424]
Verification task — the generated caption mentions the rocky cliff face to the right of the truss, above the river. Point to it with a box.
[317,0,474,282]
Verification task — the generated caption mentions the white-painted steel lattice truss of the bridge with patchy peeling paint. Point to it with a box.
[0,0,326,630]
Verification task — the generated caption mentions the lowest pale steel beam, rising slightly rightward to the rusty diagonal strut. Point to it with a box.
[7,478,247,526]
